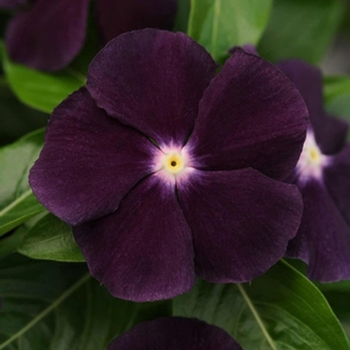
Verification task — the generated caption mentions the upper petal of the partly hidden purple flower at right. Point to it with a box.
[276,60,349,154]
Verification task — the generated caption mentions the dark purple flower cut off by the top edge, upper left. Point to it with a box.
[0,0,177,71]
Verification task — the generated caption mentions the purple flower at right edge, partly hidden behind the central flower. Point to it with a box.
[278,60,350,282]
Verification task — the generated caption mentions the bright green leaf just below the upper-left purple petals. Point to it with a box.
[3,49,85,113]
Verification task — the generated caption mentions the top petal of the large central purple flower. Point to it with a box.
[87,29,216,145]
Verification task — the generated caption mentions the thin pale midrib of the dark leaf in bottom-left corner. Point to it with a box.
[0,273,90,349]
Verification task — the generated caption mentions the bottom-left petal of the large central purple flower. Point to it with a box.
[73,175,195,301]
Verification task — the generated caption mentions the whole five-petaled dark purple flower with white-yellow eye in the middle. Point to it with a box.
[30,29,307,301]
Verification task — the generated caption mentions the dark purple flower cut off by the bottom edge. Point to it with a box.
[108,317,242,350]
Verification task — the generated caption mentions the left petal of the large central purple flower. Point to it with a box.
[29,89,156,225]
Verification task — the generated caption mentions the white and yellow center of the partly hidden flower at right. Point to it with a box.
[296,131,328,180]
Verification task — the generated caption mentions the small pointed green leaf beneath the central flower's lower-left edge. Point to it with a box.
[18,214,84,262]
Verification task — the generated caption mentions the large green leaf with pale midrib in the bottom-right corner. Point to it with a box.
[173,262,350,350]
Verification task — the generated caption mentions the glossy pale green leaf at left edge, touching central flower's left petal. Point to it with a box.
[0,130,44,236]
